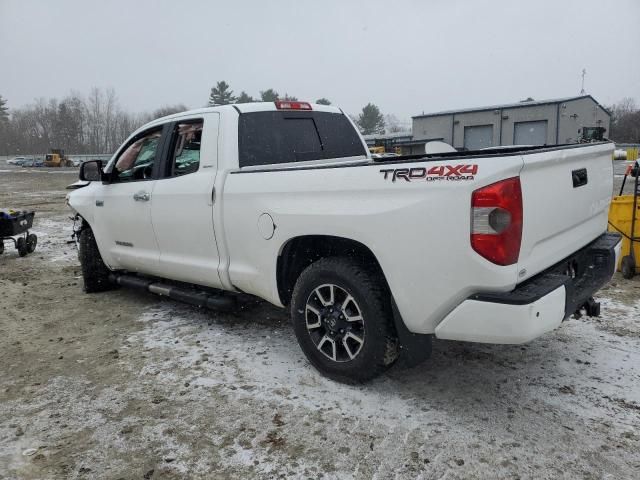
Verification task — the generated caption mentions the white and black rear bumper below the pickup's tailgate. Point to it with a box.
[435,233,621,344]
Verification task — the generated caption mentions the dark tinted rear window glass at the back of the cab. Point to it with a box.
[238,111,366,167]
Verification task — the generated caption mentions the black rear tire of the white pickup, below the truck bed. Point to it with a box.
[291,257,398,383]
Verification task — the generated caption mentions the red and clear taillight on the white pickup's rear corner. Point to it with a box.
[471,177,522,265]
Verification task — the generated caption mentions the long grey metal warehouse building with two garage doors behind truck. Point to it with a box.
[407,95,611,153]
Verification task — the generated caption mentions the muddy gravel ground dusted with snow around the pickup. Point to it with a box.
[0,167,640,479]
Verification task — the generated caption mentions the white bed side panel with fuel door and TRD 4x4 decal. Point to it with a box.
[223,156,522,333]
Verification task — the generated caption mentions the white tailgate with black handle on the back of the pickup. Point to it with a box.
[518,143,614,282]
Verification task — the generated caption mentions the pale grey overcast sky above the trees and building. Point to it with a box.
[0,0,640,119]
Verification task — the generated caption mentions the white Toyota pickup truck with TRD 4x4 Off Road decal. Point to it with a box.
[68,101,620,382]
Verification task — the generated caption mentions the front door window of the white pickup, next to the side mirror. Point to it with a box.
[111,129,162,182]
